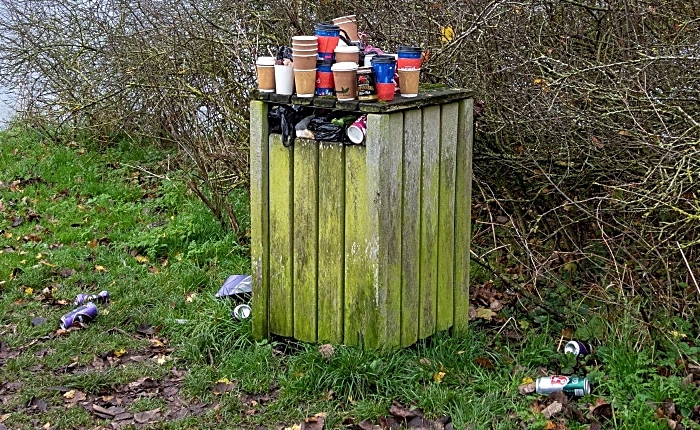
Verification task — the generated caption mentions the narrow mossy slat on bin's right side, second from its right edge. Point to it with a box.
[436,103,459,330]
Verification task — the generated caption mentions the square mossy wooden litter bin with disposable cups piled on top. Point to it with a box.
[250,90,473,349]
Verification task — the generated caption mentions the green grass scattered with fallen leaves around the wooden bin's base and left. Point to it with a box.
[0,130,700,429]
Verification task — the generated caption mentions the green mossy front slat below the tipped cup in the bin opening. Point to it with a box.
[343,146,379,345]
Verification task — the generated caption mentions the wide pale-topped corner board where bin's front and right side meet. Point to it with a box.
[367,113,404,349]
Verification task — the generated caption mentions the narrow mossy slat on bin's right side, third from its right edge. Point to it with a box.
[418,106,440,338]
